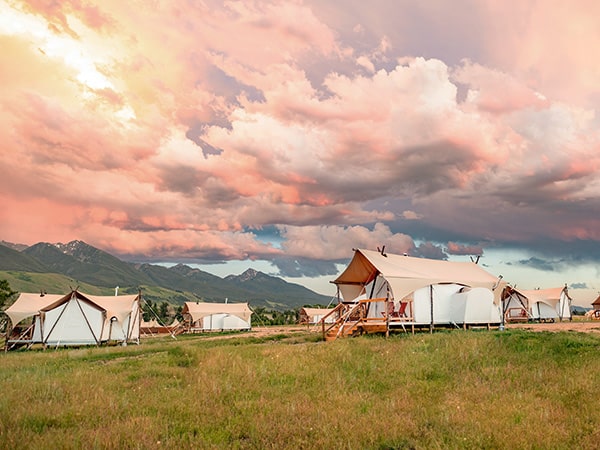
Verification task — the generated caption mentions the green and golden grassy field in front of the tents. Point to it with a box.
[0,330,600,449]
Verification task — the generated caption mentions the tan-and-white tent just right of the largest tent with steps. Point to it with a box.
[503,285,572,322]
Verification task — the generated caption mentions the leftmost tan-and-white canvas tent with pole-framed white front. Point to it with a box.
[5,290,141,349]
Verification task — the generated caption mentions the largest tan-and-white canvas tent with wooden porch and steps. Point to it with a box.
[323,249,506,338]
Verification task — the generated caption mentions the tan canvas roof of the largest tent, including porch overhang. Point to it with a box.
[334,249,506,298]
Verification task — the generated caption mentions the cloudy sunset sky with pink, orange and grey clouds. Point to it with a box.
[0,0,600,306]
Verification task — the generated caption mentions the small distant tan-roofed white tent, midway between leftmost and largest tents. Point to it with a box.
[182,302,252,331]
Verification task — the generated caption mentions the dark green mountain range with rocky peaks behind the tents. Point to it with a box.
[0,240,331,310]
